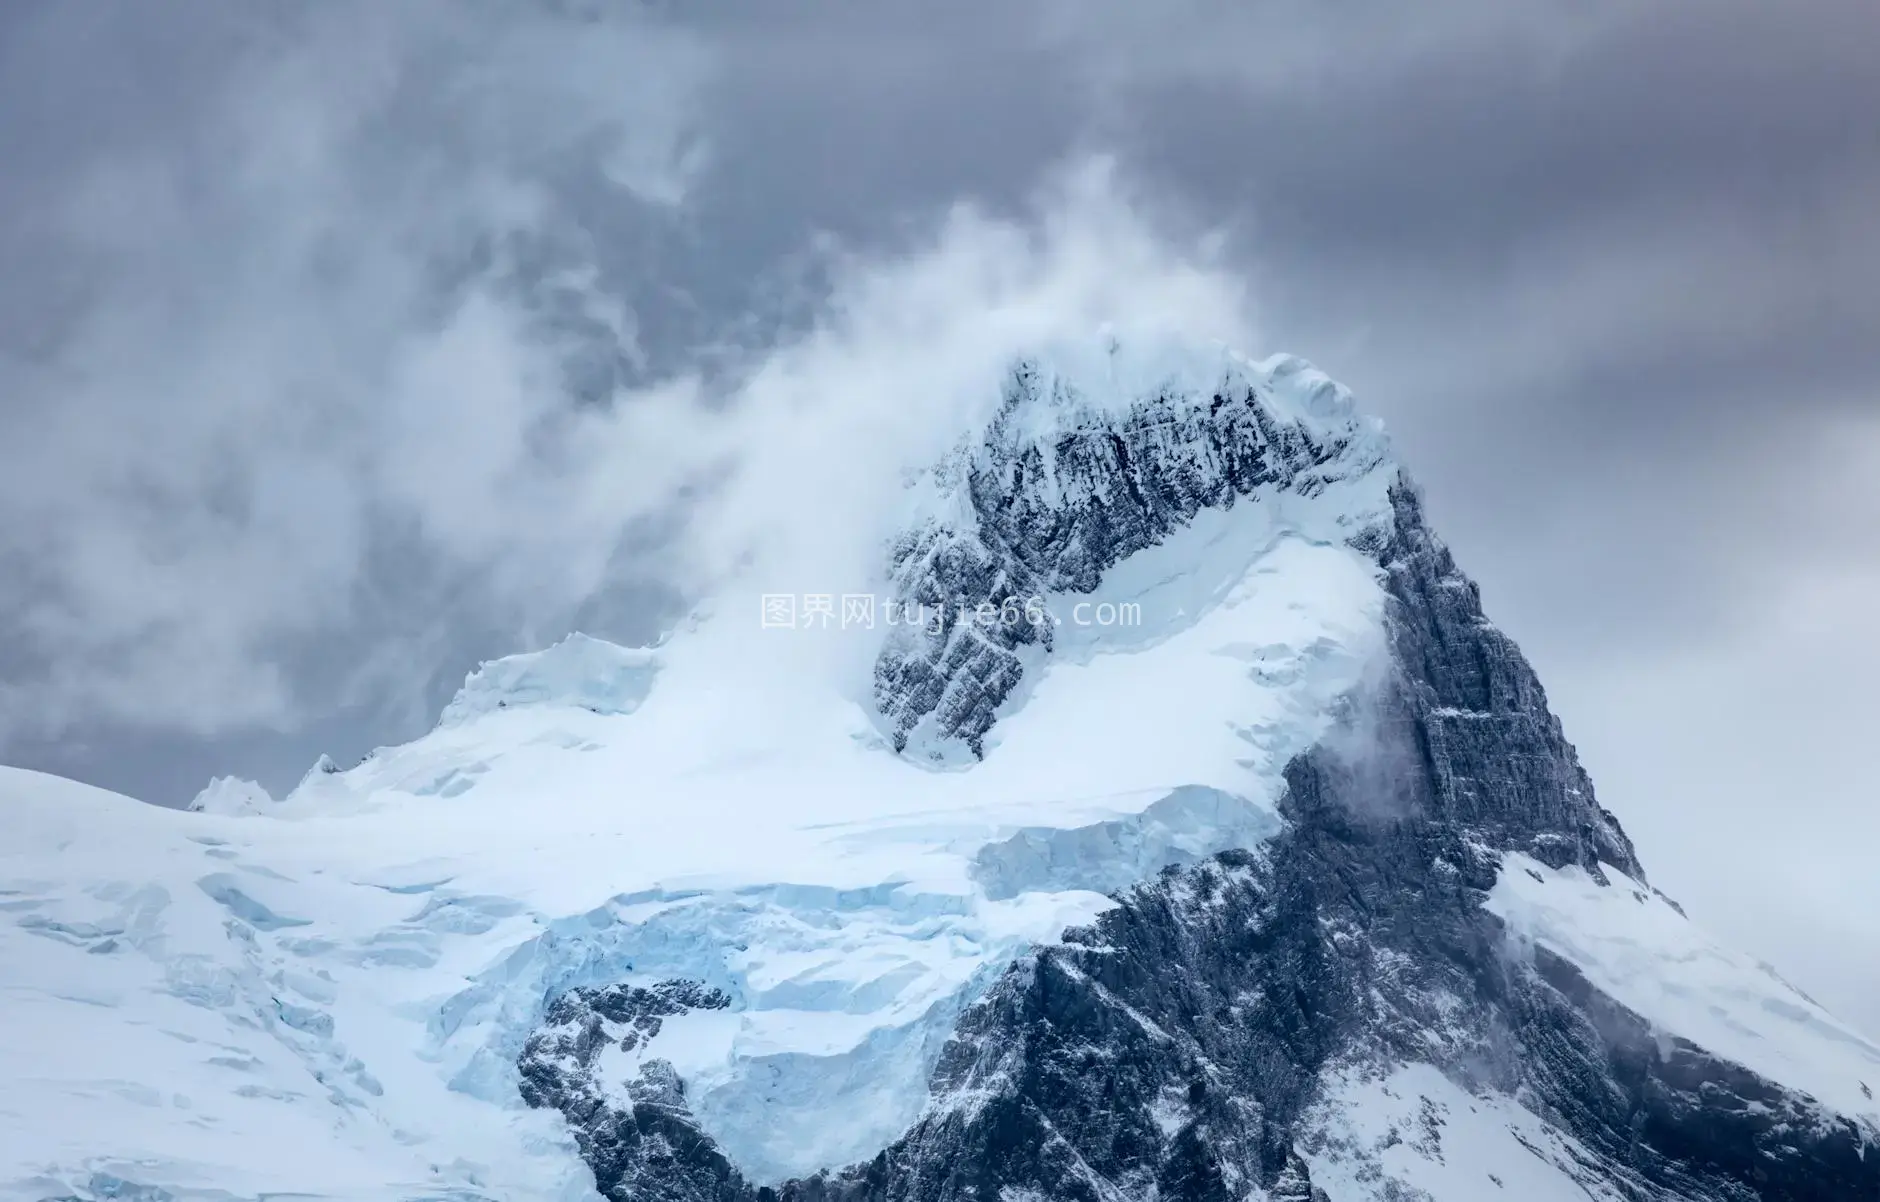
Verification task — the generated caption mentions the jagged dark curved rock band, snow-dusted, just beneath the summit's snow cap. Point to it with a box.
[874,359,1382,756]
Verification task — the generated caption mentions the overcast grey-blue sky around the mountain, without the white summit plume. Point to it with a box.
[0,0,1880,1031]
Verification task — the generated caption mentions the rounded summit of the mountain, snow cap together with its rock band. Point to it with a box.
[874,335,1399,764]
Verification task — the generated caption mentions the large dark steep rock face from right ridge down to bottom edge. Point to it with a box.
[815,485,1880,1202]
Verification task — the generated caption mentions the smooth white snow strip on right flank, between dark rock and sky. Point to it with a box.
[1489,854,1880,1144]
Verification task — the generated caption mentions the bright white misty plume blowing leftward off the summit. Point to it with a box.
[688,160,1252,677]
